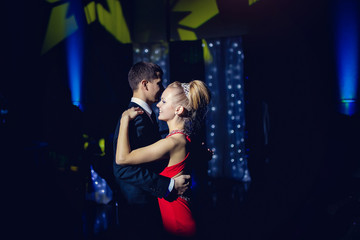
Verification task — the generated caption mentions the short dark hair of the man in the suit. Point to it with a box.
[128,62,163,91]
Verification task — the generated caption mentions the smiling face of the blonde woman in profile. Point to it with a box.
[156,88,176,121]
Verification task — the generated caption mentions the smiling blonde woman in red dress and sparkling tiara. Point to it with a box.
[116,80,210,236]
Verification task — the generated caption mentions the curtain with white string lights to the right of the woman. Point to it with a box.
[203,37,251,182]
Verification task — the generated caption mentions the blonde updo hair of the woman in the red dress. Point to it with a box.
[168,80,211,135]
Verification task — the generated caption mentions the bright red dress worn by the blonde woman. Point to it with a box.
[158,132,196,236]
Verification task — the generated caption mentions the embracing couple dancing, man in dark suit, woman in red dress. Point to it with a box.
[113,62,210,239]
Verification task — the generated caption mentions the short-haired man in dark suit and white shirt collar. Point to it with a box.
[113,62,190,238]
